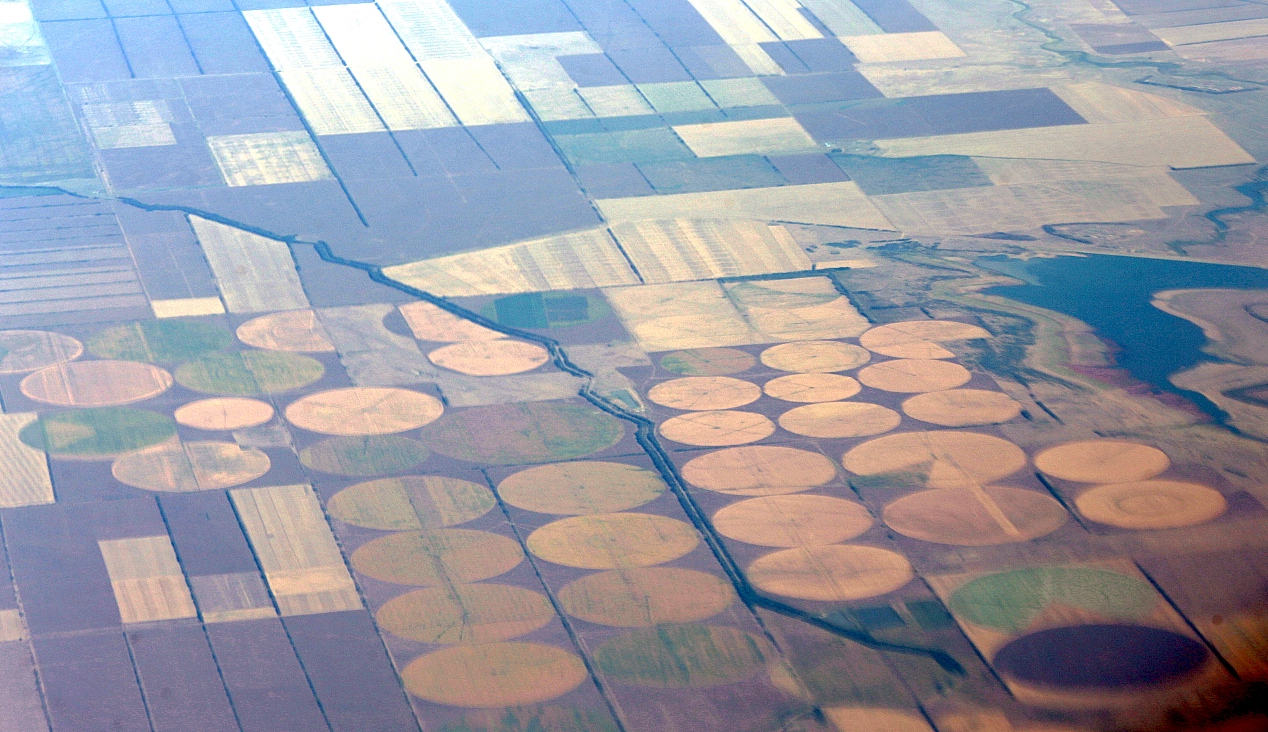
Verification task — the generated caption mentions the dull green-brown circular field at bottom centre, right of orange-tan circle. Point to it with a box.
[595,625,772,689]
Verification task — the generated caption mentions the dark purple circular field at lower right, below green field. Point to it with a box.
[994,624,1207,690]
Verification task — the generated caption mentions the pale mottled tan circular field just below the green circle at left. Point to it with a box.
[110,441,271,493]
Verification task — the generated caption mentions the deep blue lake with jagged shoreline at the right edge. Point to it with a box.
[976,255,1268,421]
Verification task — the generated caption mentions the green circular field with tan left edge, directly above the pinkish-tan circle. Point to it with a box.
[87,318,233,363]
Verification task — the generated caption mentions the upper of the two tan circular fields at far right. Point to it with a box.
[1035,440,1172,483]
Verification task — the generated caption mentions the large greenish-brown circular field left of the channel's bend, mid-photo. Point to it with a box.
[422,402,625,466]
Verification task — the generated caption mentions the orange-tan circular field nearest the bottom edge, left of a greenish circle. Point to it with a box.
[401,642,587,709]
